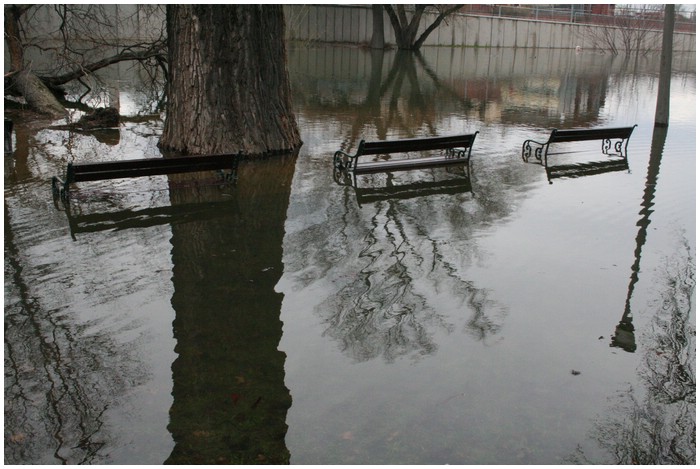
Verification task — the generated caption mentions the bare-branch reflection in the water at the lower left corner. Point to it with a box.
[5,228,145,464]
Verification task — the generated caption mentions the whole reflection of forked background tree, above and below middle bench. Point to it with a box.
[285,51,512,361]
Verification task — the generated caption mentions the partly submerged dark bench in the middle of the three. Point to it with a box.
[333,132,479,176]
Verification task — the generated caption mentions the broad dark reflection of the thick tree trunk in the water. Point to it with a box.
[166,155,296,464]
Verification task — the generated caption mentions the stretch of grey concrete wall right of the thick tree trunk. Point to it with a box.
[285,5,695,52]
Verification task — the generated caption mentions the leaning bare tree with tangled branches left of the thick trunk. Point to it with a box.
[4,4,166,117]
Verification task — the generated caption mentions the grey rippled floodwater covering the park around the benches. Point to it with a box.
[4,46,696,464]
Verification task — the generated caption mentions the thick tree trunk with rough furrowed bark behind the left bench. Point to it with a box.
[160,5,301,155]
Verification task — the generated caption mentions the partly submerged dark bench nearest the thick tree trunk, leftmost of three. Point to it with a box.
[51,154,240,202]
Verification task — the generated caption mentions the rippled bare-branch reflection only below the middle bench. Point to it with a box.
[318,194,503,361]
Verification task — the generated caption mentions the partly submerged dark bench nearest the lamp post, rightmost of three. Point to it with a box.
[522,125,637,166]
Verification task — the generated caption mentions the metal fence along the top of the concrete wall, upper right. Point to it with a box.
[462,4,696,33]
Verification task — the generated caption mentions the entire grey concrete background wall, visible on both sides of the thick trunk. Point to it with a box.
[10,4,695,52]
